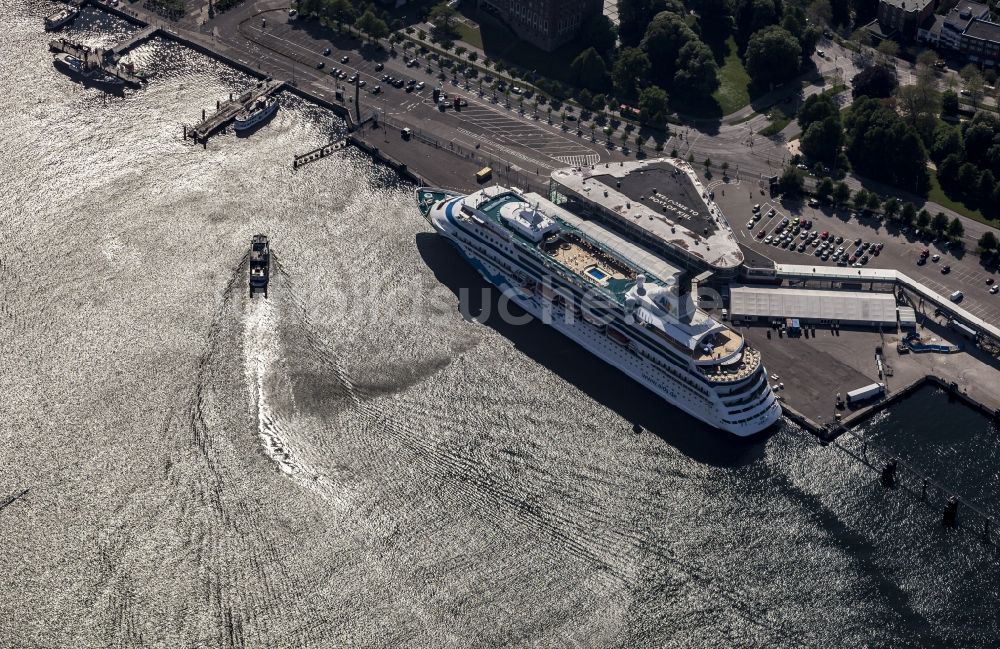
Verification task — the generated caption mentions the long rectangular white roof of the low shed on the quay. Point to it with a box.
[729,286,896,325]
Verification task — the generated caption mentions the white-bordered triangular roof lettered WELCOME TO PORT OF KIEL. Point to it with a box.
[552,158,743,269]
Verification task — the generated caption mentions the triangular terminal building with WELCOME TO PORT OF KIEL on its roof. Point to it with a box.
[549,158,743,282]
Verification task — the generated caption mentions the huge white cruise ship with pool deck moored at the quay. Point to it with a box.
[416,186,781,437]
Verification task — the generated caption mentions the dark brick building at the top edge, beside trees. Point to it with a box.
[478,0,603,52]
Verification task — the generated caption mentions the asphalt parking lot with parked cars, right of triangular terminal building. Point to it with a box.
[715,185,1000,321]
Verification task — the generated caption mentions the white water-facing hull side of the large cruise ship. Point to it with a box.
[427,190,781,437]
